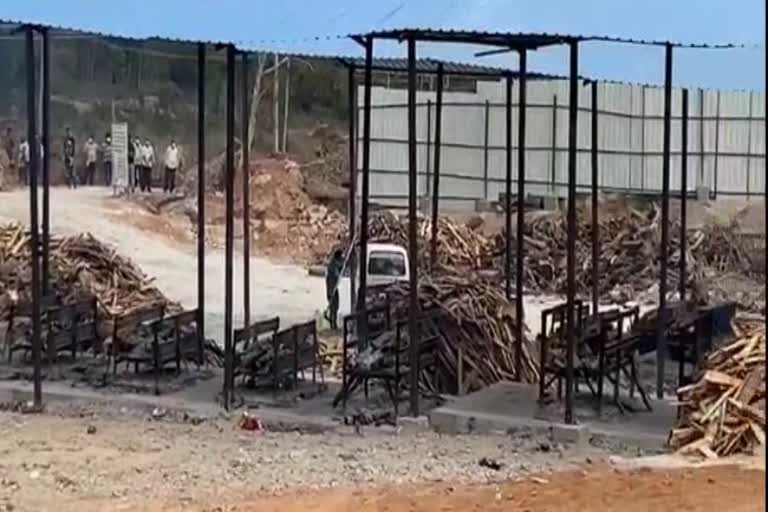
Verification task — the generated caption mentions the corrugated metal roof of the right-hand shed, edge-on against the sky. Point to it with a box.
[353,28,746,49]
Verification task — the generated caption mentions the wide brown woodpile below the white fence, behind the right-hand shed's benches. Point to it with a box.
[497,204,751,302]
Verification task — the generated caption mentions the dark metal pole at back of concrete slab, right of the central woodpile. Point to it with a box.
[515,49,528,381]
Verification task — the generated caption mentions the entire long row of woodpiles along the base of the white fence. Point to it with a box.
[356,205,765,312]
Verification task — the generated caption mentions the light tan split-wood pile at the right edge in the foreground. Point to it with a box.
[669,324,766,459]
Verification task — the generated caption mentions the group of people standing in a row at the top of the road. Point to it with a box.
[2,127,182,193]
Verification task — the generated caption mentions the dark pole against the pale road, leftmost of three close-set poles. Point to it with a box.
[198,43,206,364]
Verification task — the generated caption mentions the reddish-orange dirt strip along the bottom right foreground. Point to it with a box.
[142,466,765,512]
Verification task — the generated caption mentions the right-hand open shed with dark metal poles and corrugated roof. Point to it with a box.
[350,29,752,424]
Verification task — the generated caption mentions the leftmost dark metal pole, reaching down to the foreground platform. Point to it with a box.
[25,27,43,410]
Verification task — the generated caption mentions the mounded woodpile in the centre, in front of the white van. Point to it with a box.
[380,275,538,392]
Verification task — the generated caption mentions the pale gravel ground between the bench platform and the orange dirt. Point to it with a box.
[0,405,639,511]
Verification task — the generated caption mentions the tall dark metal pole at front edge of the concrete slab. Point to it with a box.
[565,40,579,424]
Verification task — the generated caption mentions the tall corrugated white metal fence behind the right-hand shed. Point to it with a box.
[357,80,766,209]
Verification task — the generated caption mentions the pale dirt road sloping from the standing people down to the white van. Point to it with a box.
[0,187,325,340]
